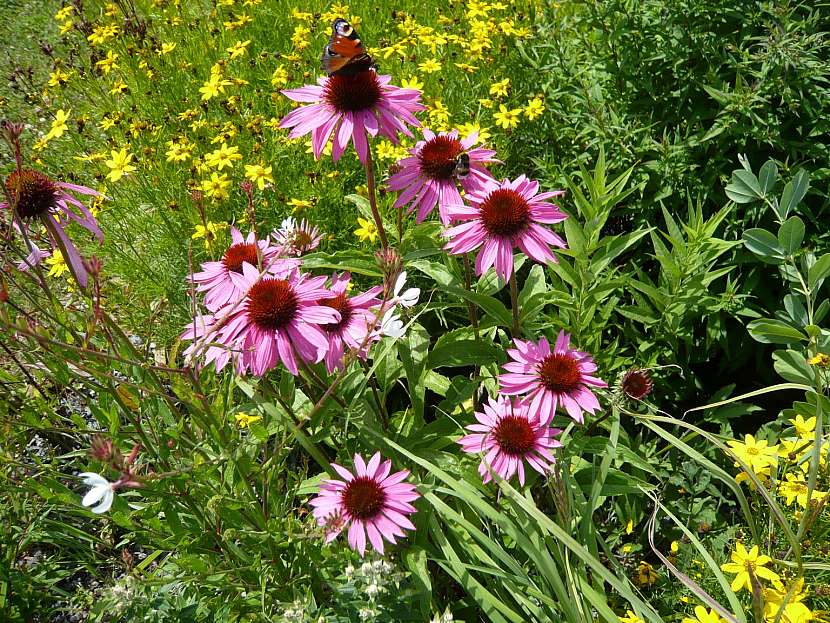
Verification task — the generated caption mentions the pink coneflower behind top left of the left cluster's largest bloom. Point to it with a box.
[191,227,300,312]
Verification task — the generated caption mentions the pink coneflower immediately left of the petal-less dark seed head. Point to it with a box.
[499,331,608,424]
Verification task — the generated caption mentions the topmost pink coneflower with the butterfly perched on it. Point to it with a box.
[280,69,425,164]
